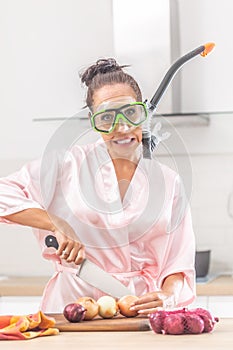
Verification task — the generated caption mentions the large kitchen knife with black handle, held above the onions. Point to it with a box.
[45,235,132,298]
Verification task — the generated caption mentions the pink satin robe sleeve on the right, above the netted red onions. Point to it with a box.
[157,177,196,307]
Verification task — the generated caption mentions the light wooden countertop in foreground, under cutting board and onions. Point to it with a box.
[0,318,233,350]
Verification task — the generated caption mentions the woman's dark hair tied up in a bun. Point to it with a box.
[80,58,142,109]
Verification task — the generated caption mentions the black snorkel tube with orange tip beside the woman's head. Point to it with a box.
[142,43,215,159]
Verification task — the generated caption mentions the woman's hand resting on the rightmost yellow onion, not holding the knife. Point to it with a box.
[128,291,176,315]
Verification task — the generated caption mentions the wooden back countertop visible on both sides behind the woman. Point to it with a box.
[0,275,233,296]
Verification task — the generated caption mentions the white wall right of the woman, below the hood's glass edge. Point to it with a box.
[157,113,233,274]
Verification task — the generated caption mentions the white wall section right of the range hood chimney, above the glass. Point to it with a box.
[177,0,233,112]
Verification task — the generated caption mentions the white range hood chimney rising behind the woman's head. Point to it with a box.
[113,0,172,113]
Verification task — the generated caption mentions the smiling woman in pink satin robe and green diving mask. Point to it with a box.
[0,59,195,315]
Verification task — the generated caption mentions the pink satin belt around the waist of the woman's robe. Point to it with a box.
[55,261,158,291]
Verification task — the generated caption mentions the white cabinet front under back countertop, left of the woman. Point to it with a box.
[0,296,41,315]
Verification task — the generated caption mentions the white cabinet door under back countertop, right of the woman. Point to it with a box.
[209,295,233,317]
